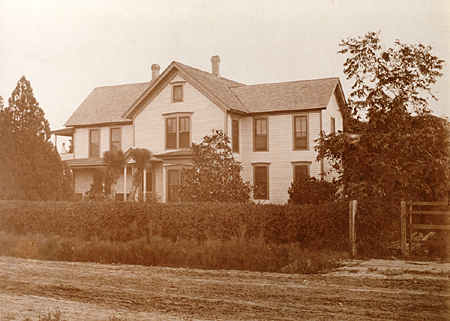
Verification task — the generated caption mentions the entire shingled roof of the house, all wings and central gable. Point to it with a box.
[64,61,345,127]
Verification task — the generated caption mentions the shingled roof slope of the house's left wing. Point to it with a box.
[64,82,150,127]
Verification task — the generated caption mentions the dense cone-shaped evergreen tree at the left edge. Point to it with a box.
[0,77,72,200]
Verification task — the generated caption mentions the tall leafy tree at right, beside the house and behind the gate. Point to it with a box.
[317,32,450,201]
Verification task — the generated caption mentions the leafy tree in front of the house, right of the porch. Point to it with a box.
[178,130,251,203]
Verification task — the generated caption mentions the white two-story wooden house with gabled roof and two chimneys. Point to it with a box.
[53,56,345,203]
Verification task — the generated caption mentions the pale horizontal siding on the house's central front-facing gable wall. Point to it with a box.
[135,76,225,154]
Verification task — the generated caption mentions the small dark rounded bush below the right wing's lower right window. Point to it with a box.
[288,175,338,205]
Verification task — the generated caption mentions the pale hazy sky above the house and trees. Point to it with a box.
[0,0,450,129]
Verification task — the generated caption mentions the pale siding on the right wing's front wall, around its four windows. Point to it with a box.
[241,111,320,203]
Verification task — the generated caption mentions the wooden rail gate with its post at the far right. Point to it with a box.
[401,201,450,256]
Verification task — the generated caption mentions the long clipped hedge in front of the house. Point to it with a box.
[0,201,348,250]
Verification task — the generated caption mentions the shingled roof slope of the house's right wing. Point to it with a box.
[231,78,339,113]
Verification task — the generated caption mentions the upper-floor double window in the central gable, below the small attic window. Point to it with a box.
[166,116,191,149]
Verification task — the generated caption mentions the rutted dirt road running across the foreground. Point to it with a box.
[0,257,450,320]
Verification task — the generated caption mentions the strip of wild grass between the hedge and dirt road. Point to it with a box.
[0,232,346,274]
